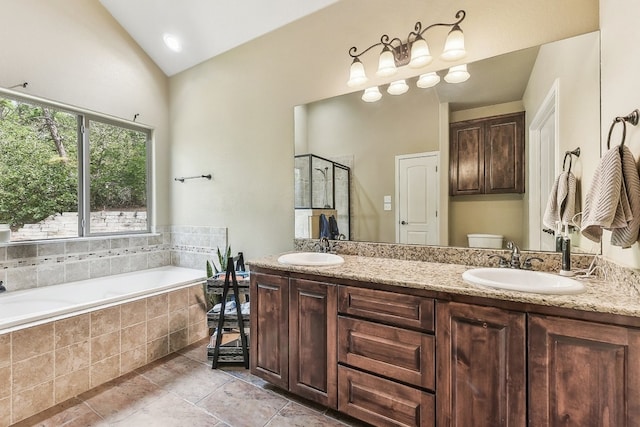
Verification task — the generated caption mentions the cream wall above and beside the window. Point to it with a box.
[0,0,170,225]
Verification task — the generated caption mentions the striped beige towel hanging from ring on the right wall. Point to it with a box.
[581,145,640,248]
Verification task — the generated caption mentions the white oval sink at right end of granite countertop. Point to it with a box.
[462,268,585,295]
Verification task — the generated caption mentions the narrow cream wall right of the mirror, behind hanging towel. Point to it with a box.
[600,0,640,268]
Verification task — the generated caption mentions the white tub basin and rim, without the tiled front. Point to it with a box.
[0,266,205,334]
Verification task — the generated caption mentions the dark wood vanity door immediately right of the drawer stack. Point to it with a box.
[436,302,528,427]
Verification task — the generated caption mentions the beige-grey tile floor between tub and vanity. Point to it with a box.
[15,340,365,427]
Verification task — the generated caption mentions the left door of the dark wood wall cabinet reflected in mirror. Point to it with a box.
[449,122,485,196]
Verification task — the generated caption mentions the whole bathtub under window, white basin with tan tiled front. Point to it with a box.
[0,267,209,427]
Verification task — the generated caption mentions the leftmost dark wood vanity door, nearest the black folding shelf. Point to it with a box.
[249,273,289,389]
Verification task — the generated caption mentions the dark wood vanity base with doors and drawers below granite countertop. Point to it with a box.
[250,268,640,427]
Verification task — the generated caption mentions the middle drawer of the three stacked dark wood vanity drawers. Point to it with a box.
[338,316,435,390]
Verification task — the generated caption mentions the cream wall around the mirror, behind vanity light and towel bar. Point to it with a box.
[170,0,598,259]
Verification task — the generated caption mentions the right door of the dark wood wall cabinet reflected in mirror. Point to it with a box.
[484,113,524,194]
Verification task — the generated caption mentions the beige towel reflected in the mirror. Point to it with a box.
[542,171,577,230]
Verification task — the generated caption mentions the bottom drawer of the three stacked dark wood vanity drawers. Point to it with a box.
[338,366,435,427]
